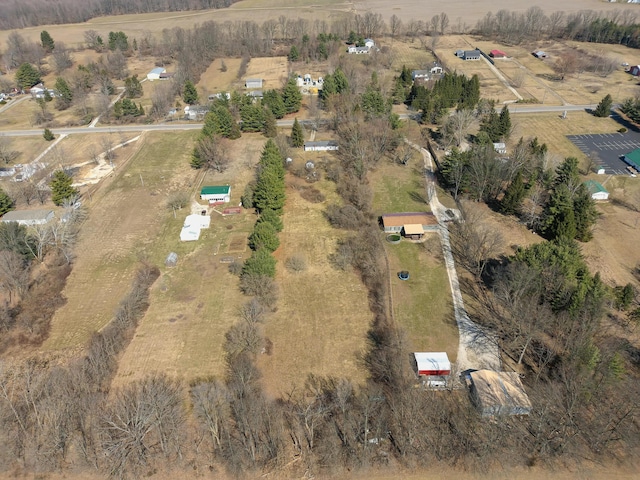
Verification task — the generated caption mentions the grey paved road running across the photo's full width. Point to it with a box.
[0,103,597,137]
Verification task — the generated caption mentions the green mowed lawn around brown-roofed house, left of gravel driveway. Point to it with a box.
[371,159,458,361]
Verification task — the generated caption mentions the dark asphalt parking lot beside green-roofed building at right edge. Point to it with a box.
[567,131,640,175]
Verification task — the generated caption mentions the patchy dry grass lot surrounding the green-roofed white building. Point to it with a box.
[116,134,265,383]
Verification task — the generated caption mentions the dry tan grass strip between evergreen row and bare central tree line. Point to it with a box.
[258,176,372,395]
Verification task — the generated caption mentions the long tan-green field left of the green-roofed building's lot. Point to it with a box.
[43,132,195,350]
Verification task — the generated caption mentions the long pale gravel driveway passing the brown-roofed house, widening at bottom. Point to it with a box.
[405,140,500,372]
